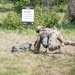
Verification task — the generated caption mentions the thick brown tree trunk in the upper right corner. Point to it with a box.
[60,0,75,27]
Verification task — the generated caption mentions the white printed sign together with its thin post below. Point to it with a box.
[22,7,34,32]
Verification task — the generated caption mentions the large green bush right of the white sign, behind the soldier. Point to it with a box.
[33,6,60,28]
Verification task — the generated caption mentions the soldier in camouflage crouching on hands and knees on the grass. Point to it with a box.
[34,26,75,52]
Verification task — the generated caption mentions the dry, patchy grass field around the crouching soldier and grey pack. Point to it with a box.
[0,2,75,75]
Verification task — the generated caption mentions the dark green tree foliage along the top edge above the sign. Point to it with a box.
[10,0,66,12]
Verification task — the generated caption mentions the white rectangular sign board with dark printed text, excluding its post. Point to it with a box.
[22,8,34,24]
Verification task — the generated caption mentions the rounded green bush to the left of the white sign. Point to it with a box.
[3,13,23,30]
